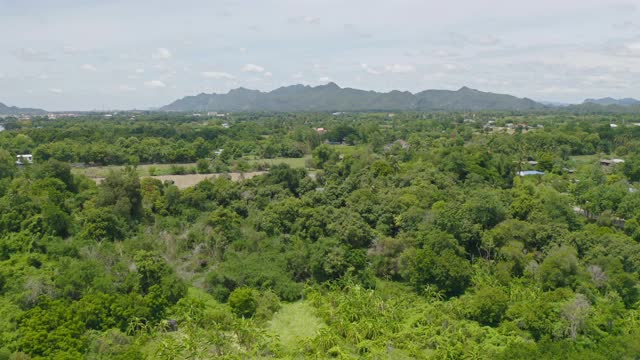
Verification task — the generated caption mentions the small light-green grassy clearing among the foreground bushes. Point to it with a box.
[268,301,324,349]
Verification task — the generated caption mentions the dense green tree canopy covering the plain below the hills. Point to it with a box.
[0,112,640,359]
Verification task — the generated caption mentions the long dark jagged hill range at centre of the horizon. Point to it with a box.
[161,83,545,112]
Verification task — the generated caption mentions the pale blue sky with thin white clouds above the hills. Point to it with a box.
[0,0,640,111]
